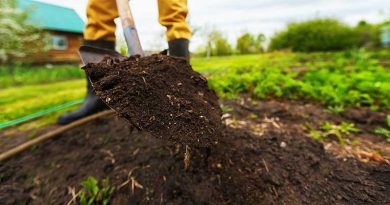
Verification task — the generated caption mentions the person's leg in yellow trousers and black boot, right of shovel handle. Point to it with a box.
[158,0,191,58]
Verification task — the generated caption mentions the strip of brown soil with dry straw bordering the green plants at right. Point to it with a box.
[220,96,390,159]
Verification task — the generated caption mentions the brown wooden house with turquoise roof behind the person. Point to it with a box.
[18,0,84,63]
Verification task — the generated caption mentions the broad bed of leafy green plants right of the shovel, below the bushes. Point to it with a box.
[203,50,390,109]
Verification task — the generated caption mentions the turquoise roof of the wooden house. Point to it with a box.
[18,0,84,33]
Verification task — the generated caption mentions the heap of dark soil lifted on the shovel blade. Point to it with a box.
[84,54,222,146]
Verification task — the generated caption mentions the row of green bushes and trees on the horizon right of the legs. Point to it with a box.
[196,18,390,57]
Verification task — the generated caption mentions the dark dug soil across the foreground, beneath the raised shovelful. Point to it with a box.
[0,114,390,205]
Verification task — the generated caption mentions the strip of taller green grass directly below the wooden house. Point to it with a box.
[0,64,84,89]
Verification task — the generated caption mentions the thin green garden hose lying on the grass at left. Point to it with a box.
[0,99,84,129]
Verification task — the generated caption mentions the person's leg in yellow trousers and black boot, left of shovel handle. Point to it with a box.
[57,0,118,124]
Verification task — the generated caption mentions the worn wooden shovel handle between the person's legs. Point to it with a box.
[116,0,144,56]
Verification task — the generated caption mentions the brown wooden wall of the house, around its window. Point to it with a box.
[25,31,83,63]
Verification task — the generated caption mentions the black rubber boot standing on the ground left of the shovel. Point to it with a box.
[57,40,115,125]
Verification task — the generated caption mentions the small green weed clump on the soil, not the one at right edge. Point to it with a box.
[309,122,360,145]
